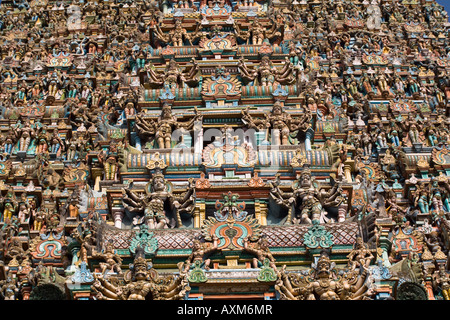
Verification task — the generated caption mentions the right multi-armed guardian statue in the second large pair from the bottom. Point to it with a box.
[270,166,343,224]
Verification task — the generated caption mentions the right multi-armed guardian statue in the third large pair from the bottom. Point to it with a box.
[242,100,312,145]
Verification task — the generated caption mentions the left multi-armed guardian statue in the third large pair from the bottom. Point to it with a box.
[135,103,202,149]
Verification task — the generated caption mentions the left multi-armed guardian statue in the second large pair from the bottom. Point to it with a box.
[123,161,194,229]
